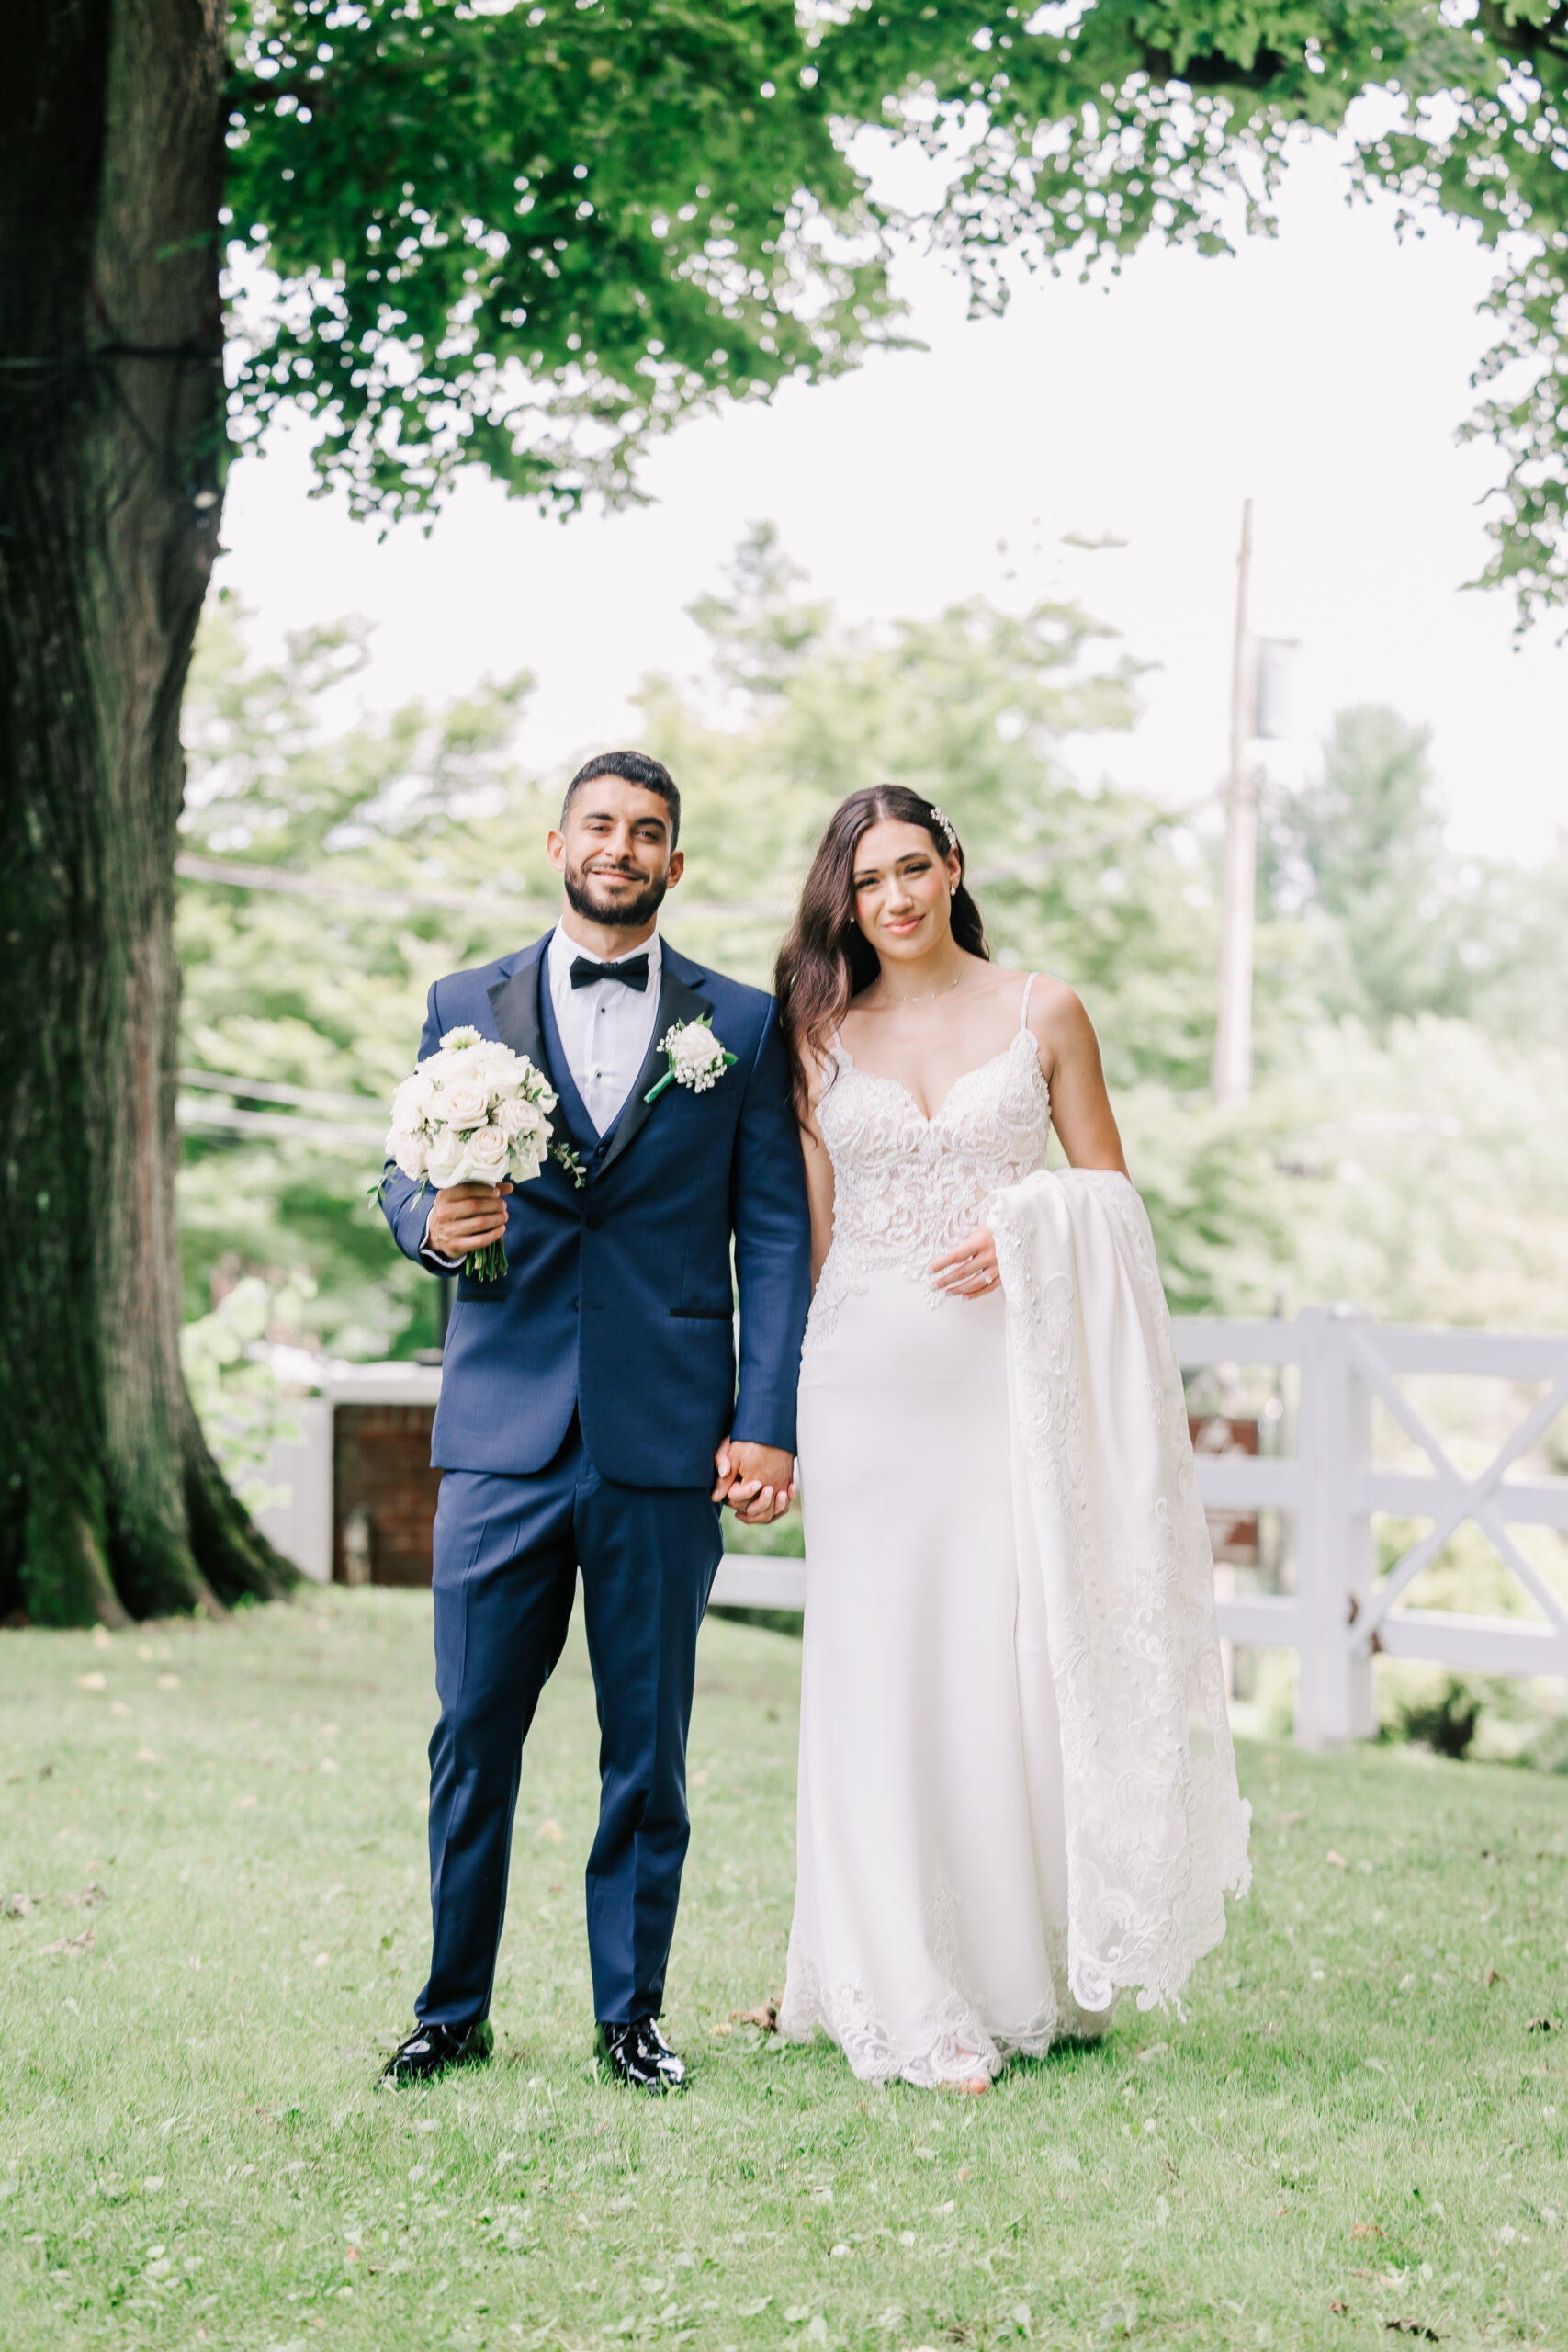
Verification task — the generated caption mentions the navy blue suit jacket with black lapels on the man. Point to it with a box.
[381,933,811,1487]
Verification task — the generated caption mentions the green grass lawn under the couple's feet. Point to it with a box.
[0,1592,1568,2352]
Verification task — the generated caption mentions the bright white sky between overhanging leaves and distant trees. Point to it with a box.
[219,126,1568,858]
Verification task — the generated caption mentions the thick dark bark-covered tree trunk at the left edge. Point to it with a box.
[0,0,291,1625]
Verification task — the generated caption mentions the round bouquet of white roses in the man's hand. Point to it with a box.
[376,1025,583,1282]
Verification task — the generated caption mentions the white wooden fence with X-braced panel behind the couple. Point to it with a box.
[261,1307,1568,1747]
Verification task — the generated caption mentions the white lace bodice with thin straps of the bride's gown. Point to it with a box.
[807,978,1051,1345]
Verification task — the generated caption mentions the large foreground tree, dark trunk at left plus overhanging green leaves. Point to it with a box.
[0,0,1568,1621]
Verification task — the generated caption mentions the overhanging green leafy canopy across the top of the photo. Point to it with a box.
[226,0,1568,614]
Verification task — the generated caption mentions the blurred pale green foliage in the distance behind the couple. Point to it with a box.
[179,526,1568,1357]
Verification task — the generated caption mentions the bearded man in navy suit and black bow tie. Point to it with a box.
[373,752,811,2091]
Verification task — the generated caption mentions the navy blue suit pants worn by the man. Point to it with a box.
[413,1416,722,2028]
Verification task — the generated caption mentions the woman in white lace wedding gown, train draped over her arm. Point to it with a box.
[776,786,1248,2091]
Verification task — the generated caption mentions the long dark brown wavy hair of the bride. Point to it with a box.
[773,783,989,1117]
